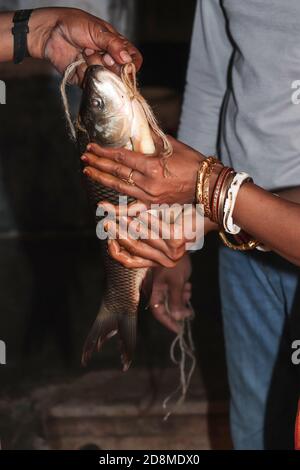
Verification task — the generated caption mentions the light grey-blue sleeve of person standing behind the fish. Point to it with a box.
[178,0,233,155]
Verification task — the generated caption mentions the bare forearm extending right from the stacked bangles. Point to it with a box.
[233,183,300,265]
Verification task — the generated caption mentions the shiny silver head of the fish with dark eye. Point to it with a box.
[79,65,133,147]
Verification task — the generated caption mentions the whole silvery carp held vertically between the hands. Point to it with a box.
[72,65,172,371]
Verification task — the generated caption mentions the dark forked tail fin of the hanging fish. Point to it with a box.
[81,304,137,372]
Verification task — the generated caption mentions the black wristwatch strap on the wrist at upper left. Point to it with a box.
[11,9,33,64]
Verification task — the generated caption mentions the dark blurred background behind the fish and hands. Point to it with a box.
[0,0,230,449]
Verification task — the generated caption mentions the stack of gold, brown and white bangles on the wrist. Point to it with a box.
[196,157,264,251]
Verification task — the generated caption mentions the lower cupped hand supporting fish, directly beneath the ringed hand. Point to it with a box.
[98,201,218,268]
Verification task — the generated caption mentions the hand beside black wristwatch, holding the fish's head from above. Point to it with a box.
[27,7,142,84]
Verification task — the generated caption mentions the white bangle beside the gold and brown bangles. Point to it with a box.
[223,172,251,235]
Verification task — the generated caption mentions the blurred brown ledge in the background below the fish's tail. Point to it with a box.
[45,369,231,450]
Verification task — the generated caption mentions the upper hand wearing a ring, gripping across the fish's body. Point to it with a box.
[82,136,204,206]
